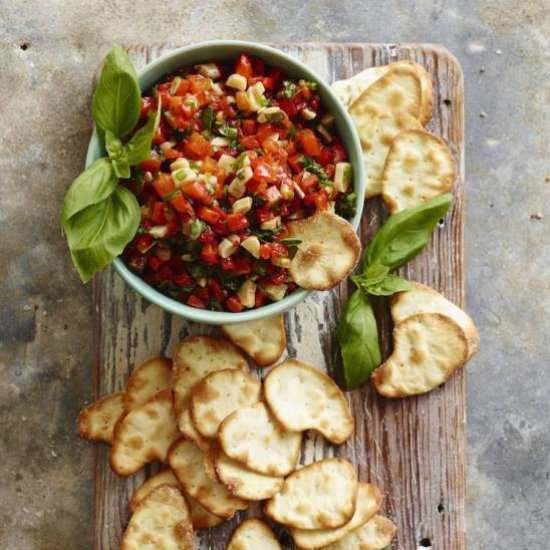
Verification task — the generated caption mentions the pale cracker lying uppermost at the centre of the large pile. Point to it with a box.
[218,403,302,476]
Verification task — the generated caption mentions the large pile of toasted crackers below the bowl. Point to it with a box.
[78,316,395,550]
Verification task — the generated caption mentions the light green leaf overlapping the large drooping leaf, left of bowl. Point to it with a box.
[61,158,118,223]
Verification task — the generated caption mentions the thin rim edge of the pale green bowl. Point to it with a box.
[86,40,365,325]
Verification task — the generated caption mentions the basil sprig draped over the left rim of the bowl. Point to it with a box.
[61,46,161,282]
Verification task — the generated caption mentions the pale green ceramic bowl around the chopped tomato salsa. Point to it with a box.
[86,40,365,325]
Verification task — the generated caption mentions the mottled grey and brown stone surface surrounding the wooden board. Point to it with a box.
[0,0,550,550]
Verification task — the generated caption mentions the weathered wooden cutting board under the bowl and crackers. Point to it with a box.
[91,44,465,550]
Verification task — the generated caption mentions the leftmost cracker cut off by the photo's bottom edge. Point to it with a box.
[120,485,194,550]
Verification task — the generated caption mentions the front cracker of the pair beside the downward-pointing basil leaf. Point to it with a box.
[372,313,468,397]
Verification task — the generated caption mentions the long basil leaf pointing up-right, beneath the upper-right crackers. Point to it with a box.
[363,193,453,271]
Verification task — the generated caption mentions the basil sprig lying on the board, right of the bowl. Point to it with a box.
[336,193,453,390]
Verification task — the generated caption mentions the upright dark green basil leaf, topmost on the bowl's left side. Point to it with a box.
[92,46,141,138]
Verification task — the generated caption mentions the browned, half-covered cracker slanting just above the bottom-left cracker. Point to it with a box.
[168,439,247,519]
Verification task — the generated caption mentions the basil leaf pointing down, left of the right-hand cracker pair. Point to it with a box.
[336,289,382,390]
